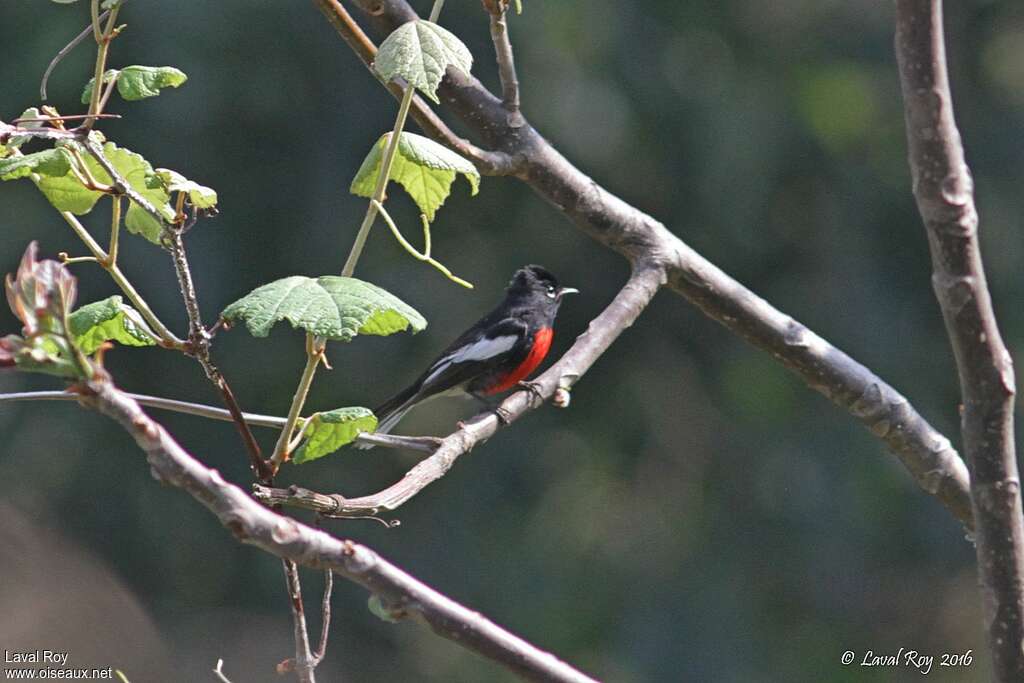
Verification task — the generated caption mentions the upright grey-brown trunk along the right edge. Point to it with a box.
[896,0,1024,683]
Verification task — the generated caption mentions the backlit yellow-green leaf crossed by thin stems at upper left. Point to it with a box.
[39,142,174,244]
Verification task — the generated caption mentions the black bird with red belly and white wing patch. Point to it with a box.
[359,265,579,449]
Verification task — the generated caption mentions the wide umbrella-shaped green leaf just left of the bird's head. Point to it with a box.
[220,275,427,342]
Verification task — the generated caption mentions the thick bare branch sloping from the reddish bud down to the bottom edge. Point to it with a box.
[79,381,594,683]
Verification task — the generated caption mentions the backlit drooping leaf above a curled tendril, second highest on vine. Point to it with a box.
[349,132,480,221]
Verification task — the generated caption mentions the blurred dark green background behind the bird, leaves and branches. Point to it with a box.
[0,0,1024,683]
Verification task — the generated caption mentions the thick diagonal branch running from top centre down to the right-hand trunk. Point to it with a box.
[317,0,973,528]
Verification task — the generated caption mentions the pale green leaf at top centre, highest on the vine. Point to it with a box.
[374,19,473,104]
